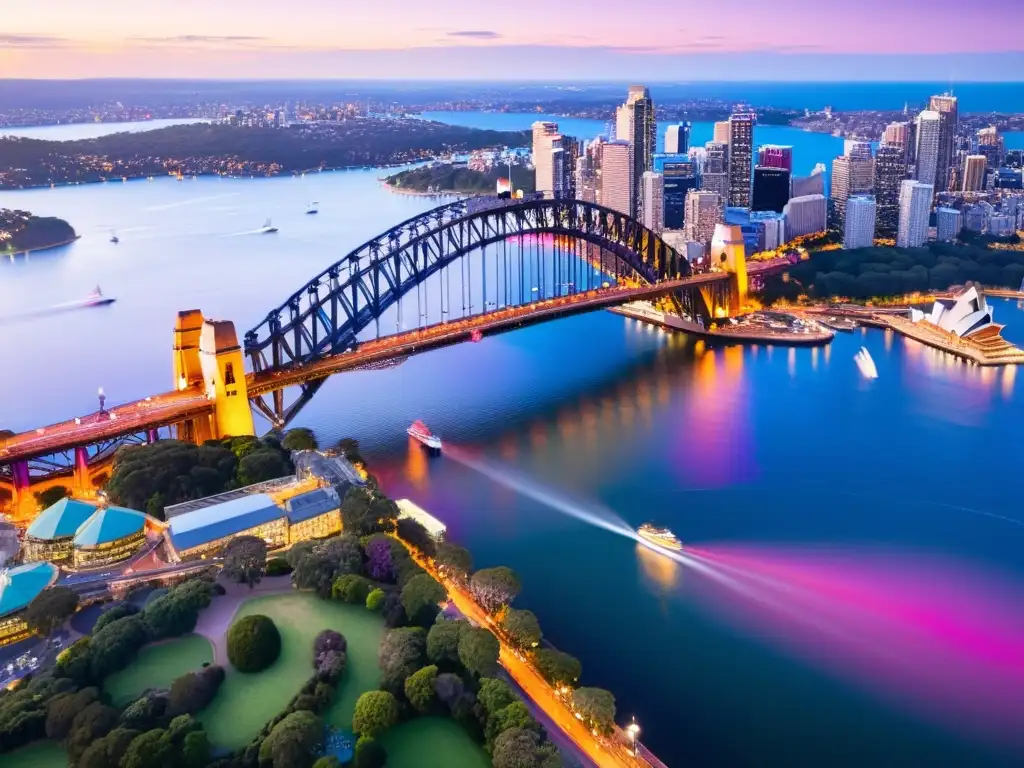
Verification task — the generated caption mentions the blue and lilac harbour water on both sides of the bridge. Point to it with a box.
[0,116,1024,766]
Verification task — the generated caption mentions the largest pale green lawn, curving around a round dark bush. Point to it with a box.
[197,593,384,753]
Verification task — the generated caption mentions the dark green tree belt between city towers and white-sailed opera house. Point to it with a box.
[761,243,1024,303]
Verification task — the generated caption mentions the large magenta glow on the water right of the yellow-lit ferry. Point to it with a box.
[687,548,1024,751]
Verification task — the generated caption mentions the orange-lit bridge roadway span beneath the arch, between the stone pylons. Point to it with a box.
[247,272,729,397]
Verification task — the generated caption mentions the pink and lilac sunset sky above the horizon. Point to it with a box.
[0,0,1024,81]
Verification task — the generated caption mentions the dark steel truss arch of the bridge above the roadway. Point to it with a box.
[245,199,691,372]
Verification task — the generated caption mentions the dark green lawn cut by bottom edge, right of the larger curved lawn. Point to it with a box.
[381,718,490,768]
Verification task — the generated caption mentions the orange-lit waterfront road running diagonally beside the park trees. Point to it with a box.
[399,540,648,768]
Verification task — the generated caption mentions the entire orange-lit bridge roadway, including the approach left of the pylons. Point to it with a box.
[0,272,729,465]
